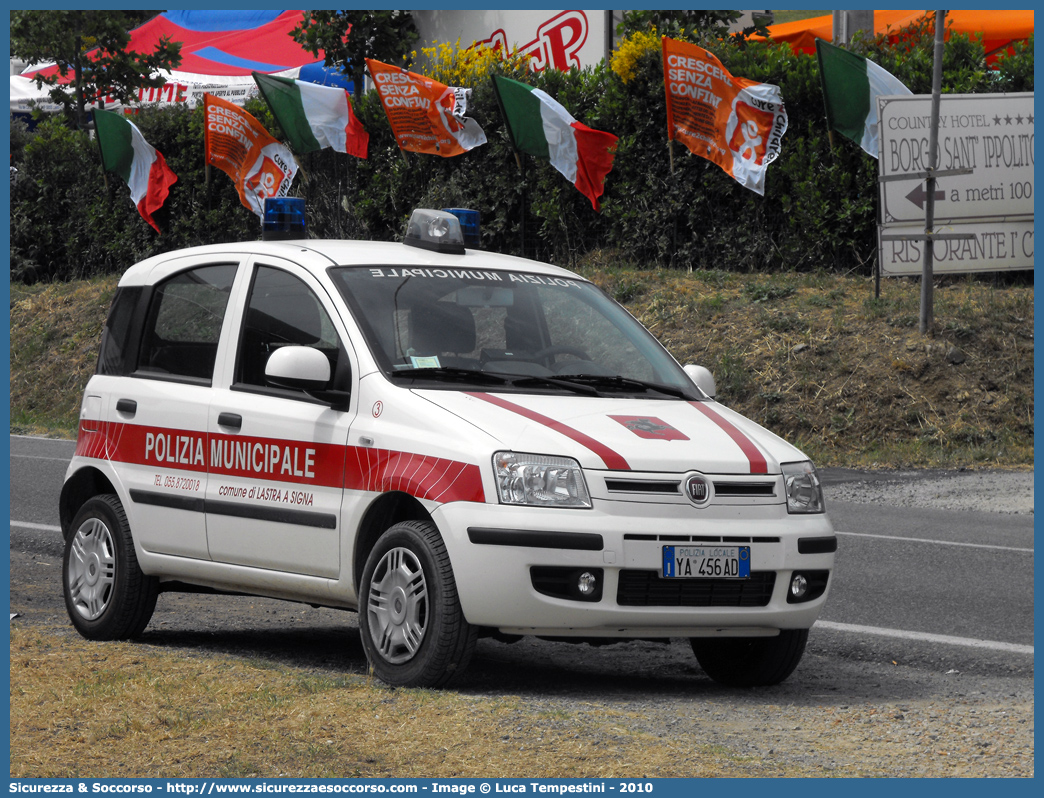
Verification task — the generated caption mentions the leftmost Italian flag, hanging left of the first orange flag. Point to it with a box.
[94,111,177,233]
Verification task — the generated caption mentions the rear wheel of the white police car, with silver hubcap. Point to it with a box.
[62,494,159,640]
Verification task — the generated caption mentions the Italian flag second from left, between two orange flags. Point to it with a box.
[253,72,370,158]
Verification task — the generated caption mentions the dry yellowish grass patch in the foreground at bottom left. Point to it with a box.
[10,625,812,779]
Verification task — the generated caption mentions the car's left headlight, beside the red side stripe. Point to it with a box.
[493,451,591,508]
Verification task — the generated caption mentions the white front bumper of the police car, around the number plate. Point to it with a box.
[433,500,835,637]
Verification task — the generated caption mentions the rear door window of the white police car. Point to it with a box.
[138,263,237,382]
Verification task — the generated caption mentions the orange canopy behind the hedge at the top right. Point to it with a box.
[752,9,1034,62]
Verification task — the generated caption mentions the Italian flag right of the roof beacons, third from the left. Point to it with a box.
[493,75,618,211]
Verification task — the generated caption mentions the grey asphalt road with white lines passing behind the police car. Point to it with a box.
[10,436,1034,677]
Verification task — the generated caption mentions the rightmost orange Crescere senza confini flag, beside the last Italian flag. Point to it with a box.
[663,37,787,195]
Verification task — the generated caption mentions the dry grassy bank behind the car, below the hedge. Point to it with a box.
[10,266,1034,468]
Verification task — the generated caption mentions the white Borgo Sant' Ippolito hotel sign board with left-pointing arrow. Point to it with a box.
[878,93,1034,224]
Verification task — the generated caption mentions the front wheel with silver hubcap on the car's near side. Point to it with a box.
[359,521,478,687]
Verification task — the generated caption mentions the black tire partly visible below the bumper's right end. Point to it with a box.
[689,629,808,687]
